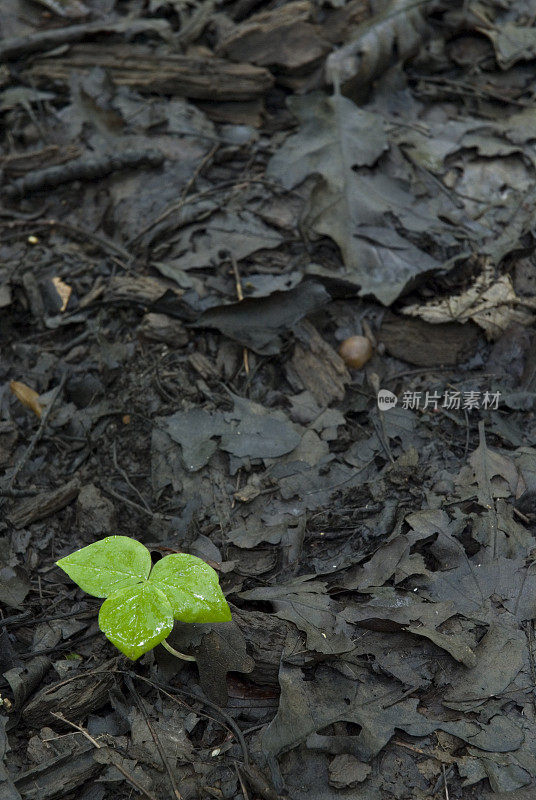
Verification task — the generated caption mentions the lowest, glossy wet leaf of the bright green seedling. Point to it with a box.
[99,582,173,661]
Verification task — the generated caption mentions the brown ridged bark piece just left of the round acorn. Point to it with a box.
[287,321,351,406]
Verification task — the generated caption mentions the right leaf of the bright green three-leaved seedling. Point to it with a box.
[149,553,231,622]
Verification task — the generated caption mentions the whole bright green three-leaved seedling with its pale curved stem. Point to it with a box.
[56,536,231,661]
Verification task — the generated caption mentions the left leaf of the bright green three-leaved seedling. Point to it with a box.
[56,536,151,597]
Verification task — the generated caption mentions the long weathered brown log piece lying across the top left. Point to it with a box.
[23,44,274,101]
